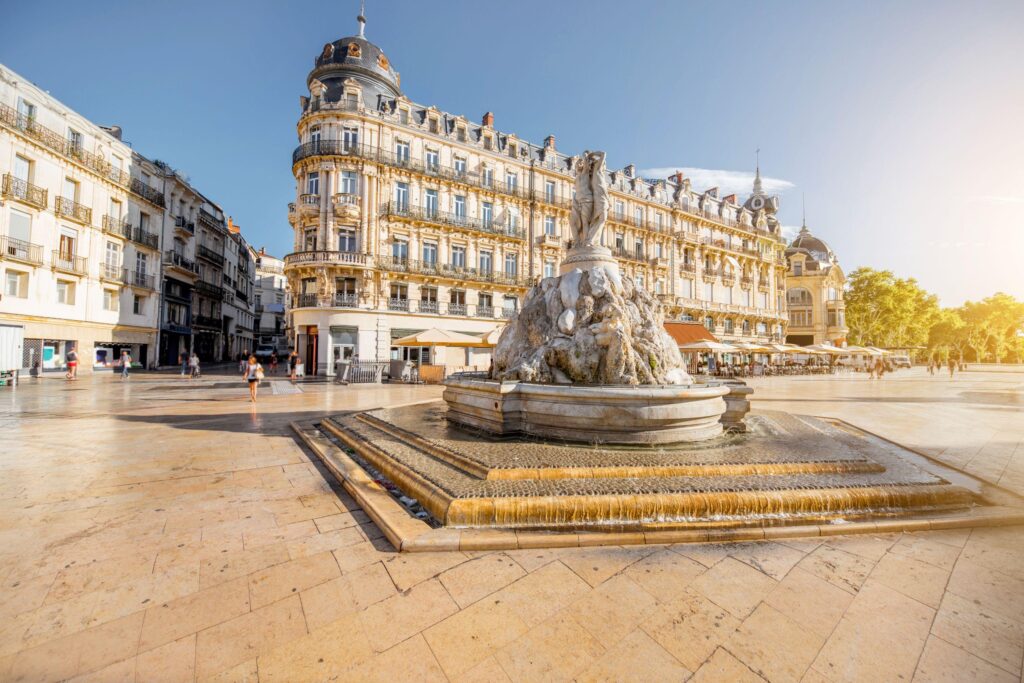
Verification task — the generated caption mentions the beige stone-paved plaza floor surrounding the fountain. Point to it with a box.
[0,368,1024,681]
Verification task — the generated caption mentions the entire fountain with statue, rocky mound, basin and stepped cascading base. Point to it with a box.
[293,152,1024,550]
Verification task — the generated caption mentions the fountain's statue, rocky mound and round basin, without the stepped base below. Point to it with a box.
[444,152,729,443]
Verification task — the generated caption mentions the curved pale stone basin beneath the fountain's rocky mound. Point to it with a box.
[443,377,730,444]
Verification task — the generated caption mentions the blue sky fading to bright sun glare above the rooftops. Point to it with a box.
[0,0,1024,305]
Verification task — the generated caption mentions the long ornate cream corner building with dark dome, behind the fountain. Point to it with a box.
[285,17,786,374]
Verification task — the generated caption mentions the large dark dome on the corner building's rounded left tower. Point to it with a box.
[306,30,401,103]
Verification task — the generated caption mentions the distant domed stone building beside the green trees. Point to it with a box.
[785,224,850,346]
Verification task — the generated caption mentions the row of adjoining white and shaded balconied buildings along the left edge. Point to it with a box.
[0,65,253,372]
